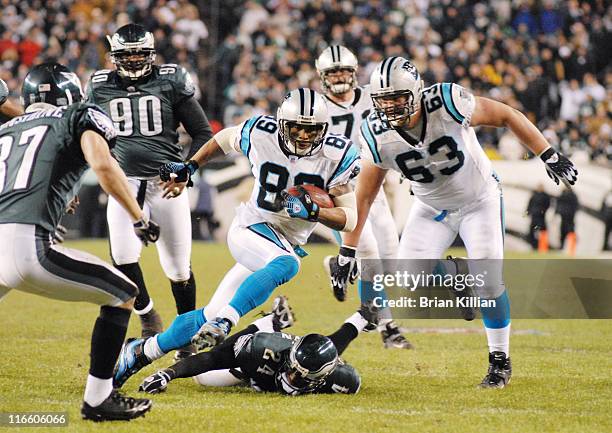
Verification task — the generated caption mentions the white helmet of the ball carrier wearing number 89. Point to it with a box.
[276,88,328,156]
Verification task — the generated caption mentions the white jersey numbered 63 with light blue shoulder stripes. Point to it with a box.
[360,83,493,210]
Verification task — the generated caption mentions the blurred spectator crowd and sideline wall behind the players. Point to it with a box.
[0,0,612,255]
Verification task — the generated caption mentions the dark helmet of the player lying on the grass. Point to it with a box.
[281,334,338,392]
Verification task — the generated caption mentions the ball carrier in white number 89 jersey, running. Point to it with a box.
[160,88,359,348]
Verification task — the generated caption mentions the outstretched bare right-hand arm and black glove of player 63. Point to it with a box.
[470,97,578,186]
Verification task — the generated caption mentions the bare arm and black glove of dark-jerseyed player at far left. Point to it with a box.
[81,130,159,245]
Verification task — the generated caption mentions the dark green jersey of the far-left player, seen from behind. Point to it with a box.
[0,103,115,231]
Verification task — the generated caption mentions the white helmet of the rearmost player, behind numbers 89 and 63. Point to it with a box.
[315,45,358,94]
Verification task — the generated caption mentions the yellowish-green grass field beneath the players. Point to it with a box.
[0,241,612,433]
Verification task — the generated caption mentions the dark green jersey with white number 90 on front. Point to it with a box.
[87,64,195,179]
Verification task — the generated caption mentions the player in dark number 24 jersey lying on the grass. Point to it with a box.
[140,304,378,395]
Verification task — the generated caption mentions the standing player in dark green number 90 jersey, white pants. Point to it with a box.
[88,24,212,356]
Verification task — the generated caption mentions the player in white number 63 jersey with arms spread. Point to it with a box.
[339,57,577,388]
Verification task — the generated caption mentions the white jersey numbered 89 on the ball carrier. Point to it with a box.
[228,116,359,245]
